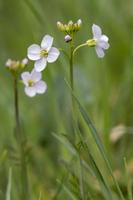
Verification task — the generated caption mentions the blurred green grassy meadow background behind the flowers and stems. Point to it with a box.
[0,0,133,200]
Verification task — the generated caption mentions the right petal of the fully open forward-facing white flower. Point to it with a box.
[47,47,60,63]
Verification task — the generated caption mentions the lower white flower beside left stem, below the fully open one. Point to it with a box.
[21,70,47,97]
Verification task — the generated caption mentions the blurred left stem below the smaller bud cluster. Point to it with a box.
[13,74,29,200]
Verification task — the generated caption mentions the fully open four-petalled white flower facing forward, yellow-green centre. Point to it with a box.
[28,35,60,72]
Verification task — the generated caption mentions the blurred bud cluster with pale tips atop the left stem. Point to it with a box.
[5,58,28,71]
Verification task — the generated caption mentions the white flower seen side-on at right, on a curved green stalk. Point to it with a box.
[87,24,109,58]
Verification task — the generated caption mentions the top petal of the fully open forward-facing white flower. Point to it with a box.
[41,35,54,51]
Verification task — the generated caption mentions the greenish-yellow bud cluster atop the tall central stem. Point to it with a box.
[57,19,82,35]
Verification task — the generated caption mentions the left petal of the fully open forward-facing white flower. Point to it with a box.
[27,44,41,60]
